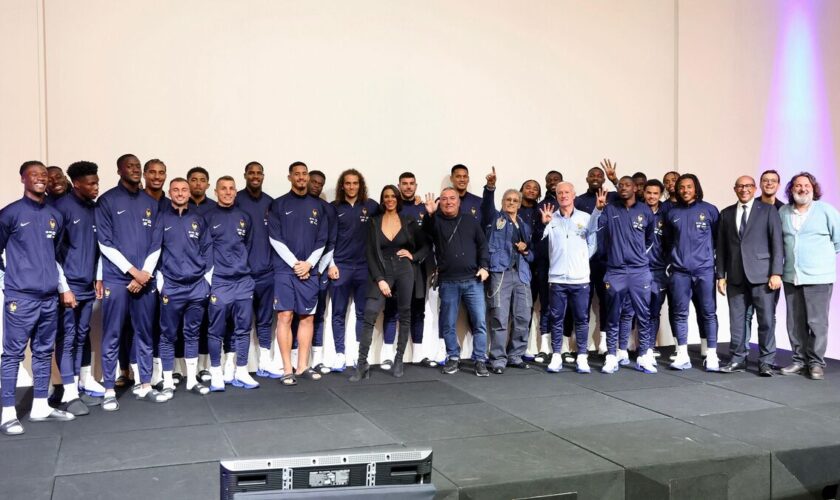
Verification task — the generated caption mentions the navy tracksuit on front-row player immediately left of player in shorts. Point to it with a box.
[204,205,254,366]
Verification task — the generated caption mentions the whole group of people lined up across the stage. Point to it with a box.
[0,154,840,435]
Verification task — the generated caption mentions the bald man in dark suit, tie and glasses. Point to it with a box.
[715,175,784,377]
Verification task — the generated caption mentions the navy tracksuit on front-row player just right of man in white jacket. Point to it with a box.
[598,199,655,355]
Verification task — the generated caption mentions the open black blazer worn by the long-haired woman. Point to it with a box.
[365,214,429,297]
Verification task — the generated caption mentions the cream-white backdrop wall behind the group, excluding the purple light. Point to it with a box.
[0,0,840,378]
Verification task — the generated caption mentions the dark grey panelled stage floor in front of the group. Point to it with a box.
[0,346,840,500]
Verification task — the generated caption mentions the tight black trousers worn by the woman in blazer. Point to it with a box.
[359,255,414,365]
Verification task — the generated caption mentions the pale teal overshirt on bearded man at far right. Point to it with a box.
[779,201,840,285]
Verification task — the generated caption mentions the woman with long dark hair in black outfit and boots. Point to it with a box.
[350,185,429,382]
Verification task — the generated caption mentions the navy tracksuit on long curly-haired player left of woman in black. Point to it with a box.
[332,199,379,353]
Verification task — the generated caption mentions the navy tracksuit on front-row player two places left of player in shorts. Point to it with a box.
[158,204,213,371]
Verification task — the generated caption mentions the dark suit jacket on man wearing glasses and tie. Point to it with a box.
[715,201,784,285]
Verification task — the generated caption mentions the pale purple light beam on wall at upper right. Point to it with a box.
[761,0,840,198]
